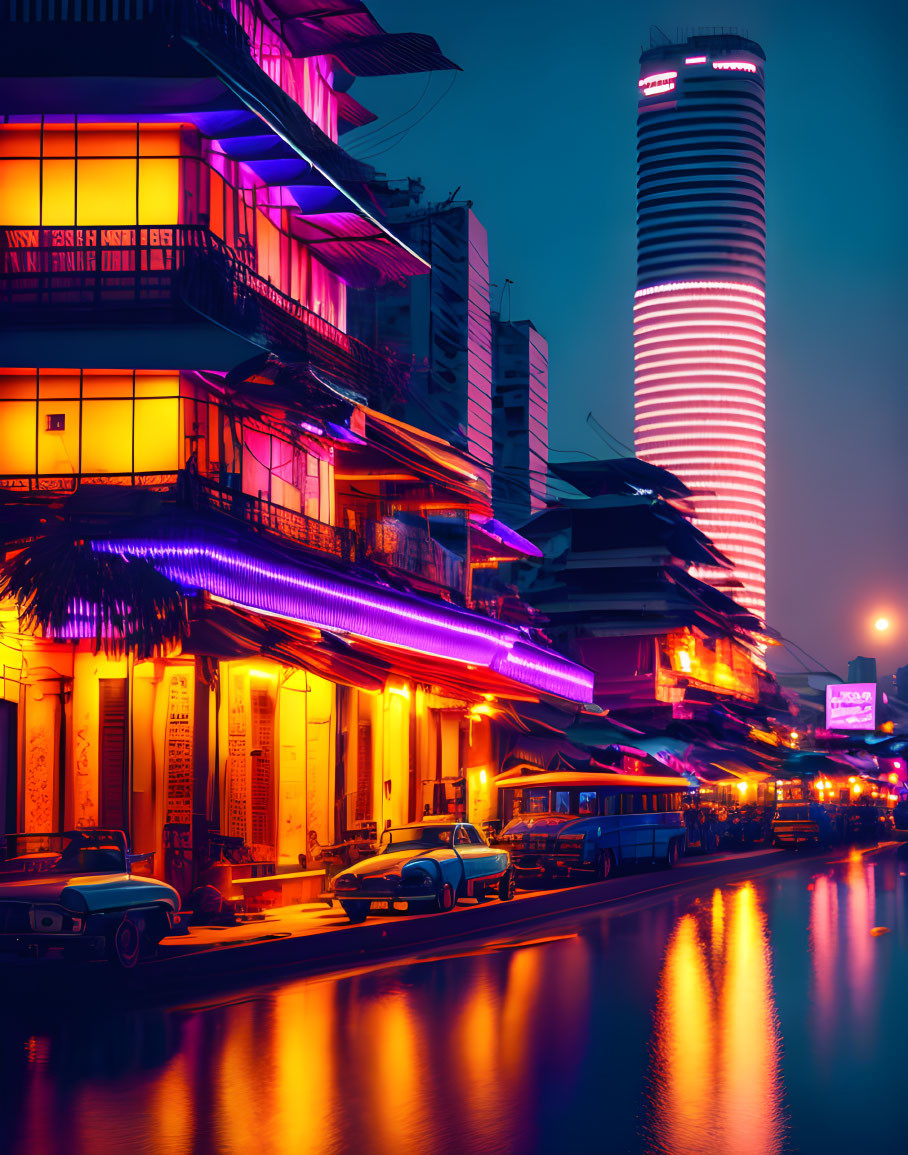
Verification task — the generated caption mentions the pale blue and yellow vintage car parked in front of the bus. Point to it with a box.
[333,821,514,923]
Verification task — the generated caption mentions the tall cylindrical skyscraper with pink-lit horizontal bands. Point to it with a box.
[634,35,766,617]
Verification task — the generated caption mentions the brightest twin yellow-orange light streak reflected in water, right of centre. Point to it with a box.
[650,882,783,1155]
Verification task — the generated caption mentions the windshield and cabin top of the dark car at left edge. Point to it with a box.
[0,830,126,880]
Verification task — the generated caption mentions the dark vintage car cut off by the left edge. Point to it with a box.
[0,828,180,968]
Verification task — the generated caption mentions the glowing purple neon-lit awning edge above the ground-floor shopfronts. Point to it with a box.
[92,536,593,702]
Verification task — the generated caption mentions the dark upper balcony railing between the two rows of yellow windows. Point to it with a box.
[0,225,408,396]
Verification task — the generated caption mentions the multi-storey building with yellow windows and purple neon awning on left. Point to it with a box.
[0,0,593,903]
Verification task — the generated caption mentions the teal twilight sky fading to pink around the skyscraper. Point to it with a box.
[344,0,908,675]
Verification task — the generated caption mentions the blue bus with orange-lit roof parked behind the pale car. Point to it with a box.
[496,772,693,886]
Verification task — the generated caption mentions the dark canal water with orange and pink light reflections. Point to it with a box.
[0,850,908,1155]
